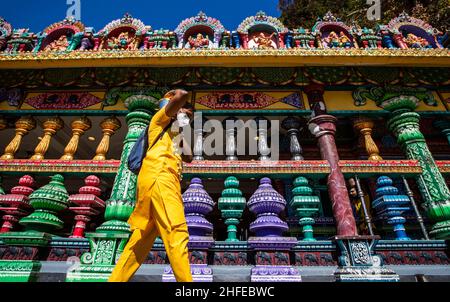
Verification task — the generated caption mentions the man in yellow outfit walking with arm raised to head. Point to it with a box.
[109,89,192,282]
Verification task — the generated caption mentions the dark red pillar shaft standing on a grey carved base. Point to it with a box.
[305,85,358,236]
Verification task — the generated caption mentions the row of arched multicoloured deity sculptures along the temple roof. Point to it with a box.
[0,11,442,54]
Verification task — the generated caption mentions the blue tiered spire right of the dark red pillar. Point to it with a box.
[372,176,410,240]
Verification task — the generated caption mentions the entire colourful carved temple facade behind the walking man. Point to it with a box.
[0,12,450,282]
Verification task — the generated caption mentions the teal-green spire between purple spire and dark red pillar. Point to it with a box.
[290,176,320,241]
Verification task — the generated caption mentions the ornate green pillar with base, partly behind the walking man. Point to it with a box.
[66,95,158,282]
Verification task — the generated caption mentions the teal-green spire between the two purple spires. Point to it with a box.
[218,176,246,241]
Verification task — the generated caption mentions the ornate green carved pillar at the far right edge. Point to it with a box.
[381,95,450,239]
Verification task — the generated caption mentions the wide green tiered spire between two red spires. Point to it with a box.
[19,174,69,232]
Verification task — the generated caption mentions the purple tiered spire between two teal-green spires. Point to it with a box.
[248,177,288,237]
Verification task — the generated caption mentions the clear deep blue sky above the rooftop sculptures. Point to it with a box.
[0,0,280,32]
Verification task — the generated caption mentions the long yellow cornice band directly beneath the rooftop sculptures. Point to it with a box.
[0,49,450,69]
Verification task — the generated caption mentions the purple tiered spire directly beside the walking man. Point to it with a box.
[183,178,214,236]
